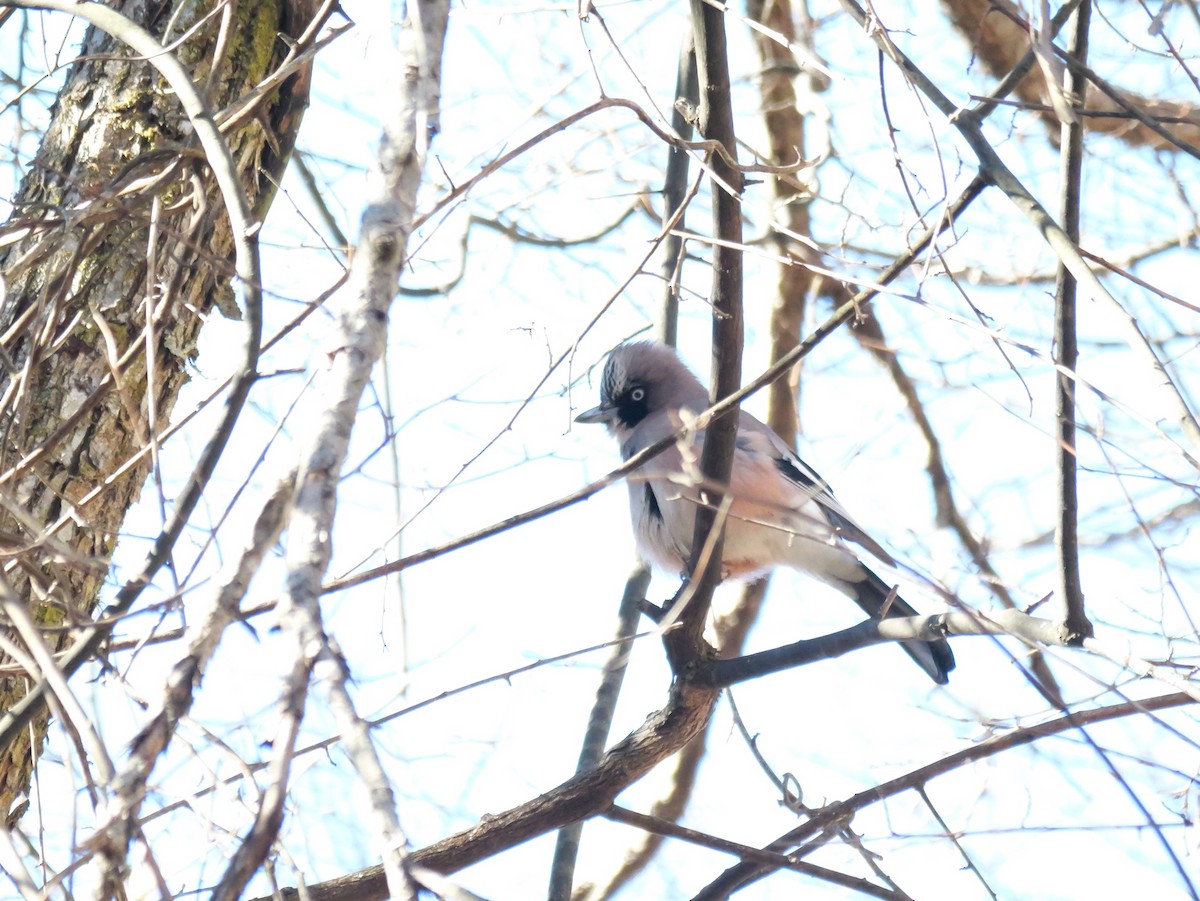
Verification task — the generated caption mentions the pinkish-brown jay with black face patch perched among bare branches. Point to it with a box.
[575,341,954,685]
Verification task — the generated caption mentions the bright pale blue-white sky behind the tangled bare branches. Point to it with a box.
[0,2,1200,901]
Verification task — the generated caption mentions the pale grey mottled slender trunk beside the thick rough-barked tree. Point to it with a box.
[265,0,450,901]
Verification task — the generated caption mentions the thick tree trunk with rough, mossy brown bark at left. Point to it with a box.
[0,0,316,818]
